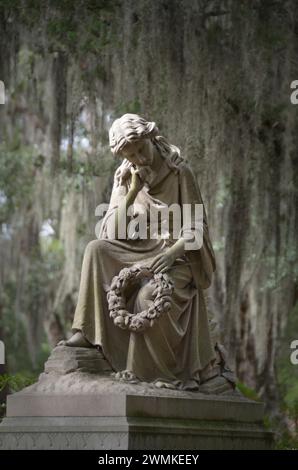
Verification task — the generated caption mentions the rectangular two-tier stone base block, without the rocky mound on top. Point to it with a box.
[0,394,272,450]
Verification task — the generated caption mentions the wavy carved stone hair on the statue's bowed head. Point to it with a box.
[109,113,182,172]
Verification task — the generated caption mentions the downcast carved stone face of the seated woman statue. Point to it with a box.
[121,138,154,166]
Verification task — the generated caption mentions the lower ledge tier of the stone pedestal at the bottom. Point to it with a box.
[0,416,272,450]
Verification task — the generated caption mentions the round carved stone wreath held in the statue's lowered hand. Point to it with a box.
[107,266,174,332]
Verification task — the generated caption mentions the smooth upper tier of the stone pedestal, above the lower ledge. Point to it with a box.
[7,386,263,422]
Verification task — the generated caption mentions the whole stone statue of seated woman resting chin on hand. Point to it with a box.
[60,114,233,389]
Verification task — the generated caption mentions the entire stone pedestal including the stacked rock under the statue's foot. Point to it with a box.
[0,347,272,450]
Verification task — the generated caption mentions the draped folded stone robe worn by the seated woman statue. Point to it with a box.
[72,156,215,388]
